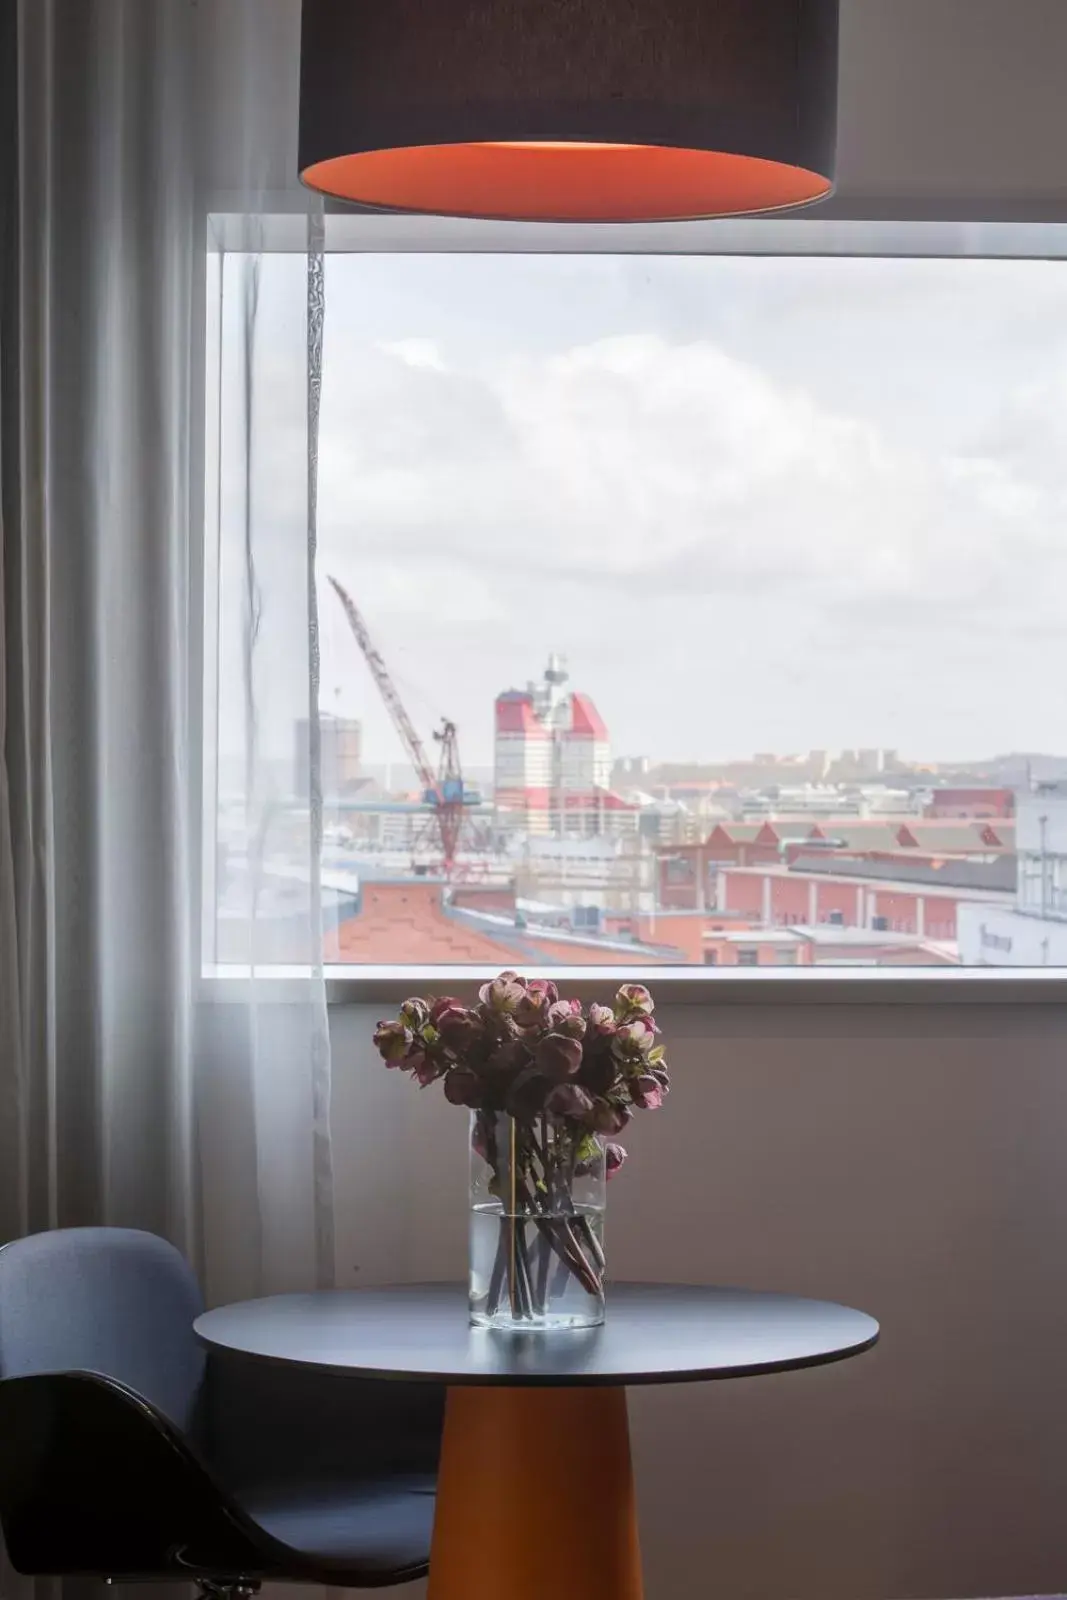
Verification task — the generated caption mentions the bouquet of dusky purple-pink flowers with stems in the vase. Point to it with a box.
[374,973,670,1320]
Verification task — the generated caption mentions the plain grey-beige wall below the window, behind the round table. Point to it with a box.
[310,1005,1067,1600]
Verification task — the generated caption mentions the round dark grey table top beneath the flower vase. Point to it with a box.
[195,1283,878,1387]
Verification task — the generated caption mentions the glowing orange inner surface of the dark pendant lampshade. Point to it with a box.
[302,142,832,222]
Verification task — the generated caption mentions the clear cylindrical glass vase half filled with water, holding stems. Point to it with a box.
[470,1110,606,1330]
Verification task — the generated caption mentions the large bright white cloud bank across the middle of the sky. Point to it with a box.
[323,323,1062,624]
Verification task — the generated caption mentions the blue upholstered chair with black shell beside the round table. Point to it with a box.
[0,1229,443,1595]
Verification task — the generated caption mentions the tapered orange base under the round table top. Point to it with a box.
[429,1386,641,1600]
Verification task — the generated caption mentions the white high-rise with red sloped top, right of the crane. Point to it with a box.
[494,656,611,835]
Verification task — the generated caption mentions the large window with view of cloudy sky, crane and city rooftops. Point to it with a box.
[205,218,1067,970]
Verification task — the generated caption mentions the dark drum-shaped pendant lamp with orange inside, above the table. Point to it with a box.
[299,0,838,222]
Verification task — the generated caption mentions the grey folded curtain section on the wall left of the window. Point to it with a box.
[0,0,198,1251]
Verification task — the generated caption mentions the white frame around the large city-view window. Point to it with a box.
[199,200,1067,1006]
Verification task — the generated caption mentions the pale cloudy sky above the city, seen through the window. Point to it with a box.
[212,254,1067,766]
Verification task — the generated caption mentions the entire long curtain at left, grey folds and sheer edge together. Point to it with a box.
[0,0,334,1298]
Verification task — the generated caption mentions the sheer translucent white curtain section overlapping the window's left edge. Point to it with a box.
[197,0,334,1293]
